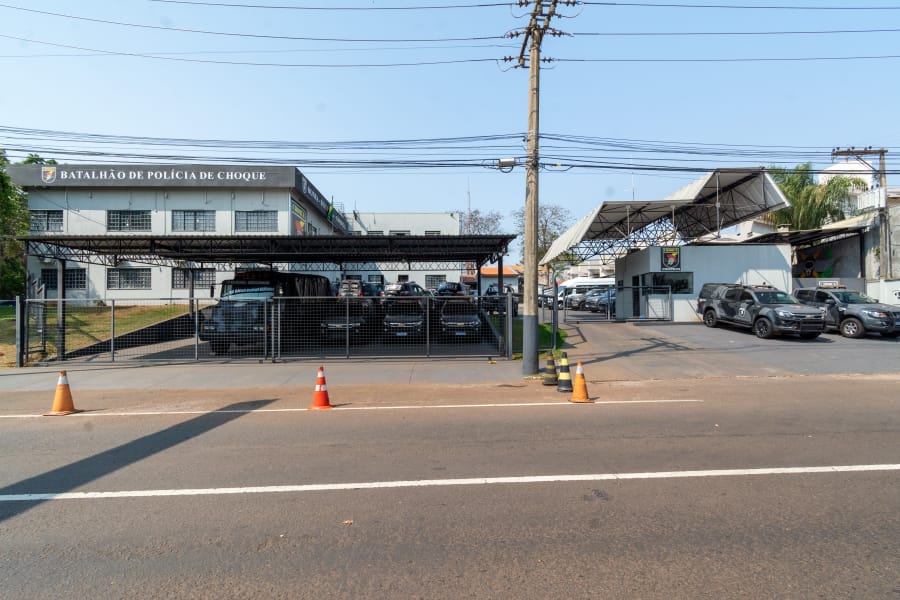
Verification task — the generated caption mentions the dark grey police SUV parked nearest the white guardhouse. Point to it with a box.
[700,285,825,339]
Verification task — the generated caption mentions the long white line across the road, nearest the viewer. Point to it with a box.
[0,464,900,502]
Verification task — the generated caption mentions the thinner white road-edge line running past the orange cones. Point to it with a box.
[0,399,703,419]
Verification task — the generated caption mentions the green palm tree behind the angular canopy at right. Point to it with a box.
[764,163,866,230]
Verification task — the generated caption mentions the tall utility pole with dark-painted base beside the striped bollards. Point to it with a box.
[519,0,558,375]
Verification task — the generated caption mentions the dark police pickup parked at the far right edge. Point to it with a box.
[794,282,900,338]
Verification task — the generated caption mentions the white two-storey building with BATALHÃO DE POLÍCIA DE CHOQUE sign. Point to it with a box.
[7,165,350,299]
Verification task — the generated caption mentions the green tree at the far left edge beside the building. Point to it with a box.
[0,149,28,298]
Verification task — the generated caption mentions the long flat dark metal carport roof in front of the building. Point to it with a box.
[21,235,516,271]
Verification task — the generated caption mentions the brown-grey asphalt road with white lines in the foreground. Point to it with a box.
[0,372,900,599]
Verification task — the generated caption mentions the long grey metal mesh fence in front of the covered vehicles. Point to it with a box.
[19,296,521,364]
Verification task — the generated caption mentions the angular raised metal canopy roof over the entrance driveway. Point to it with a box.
[541,168,788,264]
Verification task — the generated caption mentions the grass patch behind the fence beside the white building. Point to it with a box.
[0,304,188,366]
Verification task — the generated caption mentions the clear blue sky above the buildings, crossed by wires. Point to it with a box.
[0,0,900,248]
